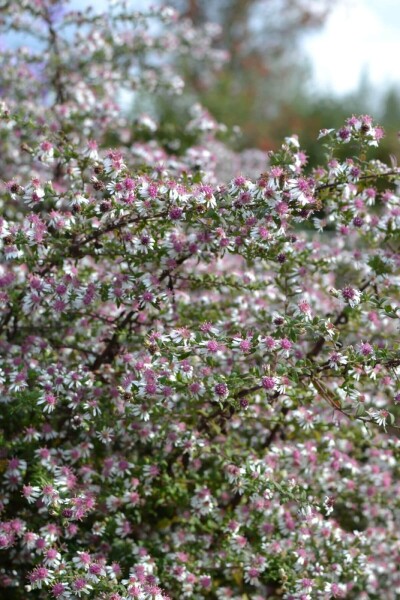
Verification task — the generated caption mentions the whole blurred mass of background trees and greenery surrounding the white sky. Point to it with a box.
[153,0,400,165]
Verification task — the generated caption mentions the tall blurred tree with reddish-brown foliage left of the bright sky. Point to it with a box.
[155,0,334,149]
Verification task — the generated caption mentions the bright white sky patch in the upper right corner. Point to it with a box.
[303,0,400,95]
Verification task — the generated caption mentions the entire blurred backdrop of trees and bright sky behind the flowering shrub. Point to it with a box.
[72,0,400,166]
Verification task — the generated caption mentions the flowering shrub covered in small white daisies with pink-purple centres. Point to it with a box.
[0,0,400,600]
